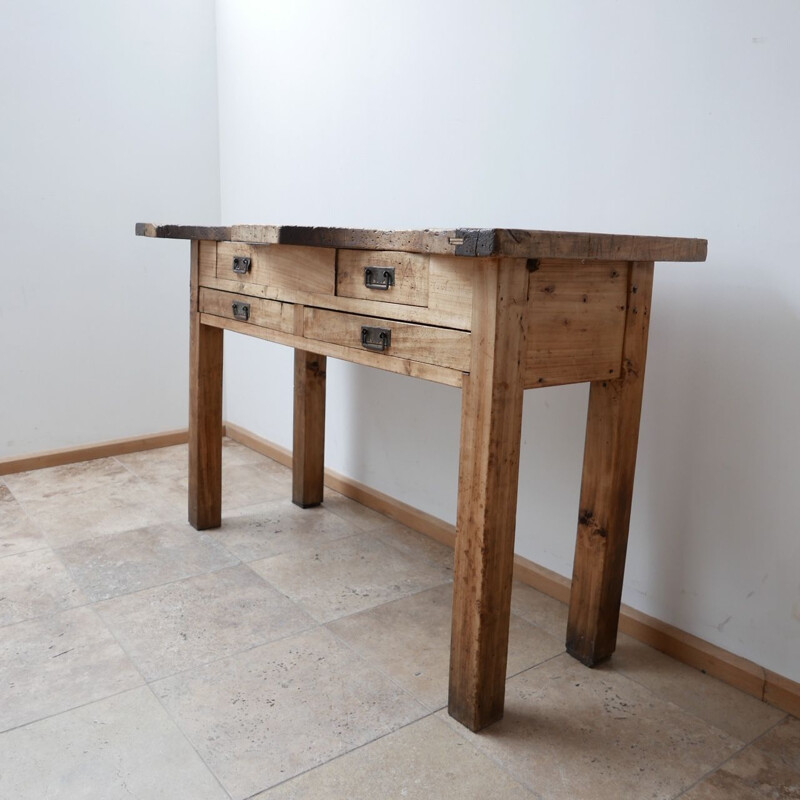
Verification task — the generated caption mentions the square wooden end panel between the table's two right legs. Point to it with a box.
[524,259,628,389]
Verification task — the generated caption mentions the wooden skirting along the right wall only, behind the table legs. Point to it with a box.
[225,423,800,716]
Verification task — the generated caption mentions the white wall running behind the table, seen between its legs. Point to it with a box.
[217,0,800,680]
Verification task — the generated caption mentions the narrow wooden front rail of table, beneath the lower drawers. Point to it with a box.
[201,309,464,387]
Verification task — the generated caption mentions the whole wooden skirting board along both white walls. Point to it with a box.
[0,423,800,716]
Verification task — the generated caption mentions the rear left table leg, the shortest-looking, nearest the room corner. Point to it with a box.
[292,349,326,508]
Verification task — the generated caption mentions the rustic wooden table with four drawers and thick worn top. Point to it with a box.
[136,223,706,731]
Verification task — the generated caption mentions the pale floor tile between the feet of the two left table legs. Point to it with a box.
[209,498,355,561]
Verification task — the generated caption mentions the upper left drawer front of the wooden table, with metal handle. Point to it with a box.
[217,242,336,300]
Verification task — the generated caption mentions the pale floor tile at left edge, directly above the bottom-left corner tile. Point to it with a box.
[0,606,142,730]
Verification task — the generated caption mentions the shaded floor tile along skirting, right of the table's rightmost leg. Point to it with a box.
[609,634,786,742]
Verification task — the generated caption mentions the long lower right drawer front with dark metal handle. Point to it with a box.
[303,308,470,372]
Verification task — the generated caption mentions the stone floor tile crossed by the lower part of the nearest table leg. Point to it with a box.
[327,584,564,709]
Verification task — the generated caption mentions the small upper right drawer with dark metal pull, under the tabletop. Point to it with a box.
[336,250,430,306]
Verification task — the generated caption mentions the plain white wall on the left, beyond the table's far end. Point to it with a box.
[0,0,219,458]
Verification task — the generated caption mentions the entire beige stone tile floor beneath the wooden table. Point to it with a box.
[0,441,800,800]
